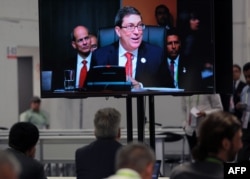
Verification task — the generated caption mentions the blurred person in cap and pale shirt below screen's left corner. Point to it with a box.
[20,96,49,129]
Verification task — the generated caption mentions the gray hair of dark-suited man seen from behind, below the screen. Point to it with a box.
[94,108,121,138]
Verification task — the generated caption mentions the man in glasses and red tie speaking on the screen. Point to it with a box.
[92,6,174,89]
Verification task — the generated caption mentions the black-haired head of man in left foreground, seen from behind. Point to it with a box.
[9,122,39,158]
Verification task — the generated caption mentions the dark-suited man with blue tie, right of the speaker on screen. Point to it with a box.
[161,28,202,92]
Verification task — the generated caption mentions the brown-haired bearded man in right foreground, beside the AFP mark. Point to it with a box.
[170,111,242,179]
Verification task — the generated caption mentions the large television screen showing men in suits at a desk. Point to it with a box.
[39,0,232,98]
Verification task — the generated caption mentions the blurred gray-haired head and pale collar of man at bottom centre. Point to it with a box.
[110,143,155,179]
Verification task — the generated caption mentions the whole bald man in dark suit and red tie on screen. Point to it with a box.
[53,25,92,90]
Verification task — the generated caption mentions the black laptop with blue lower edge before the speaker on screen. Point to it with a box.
[87,66,131,91]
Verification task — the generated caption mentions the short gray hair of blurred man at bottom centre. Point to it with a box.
[116,143,155,174]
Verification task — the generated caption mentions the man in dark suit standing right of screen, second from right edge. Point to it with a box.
[230,64,246,120]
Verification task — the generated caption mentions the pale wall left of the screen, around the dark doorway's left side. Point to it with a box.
[0,0,38,127]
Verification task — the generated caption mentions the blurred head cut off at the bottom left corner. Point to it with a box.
[0,150,20,179]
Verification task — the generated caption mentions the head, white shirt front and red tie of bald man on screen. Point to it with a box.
[68,25,92,88]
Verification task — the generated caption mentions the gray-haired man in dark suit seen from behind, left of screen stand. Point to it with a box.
[75,108,122,179]
